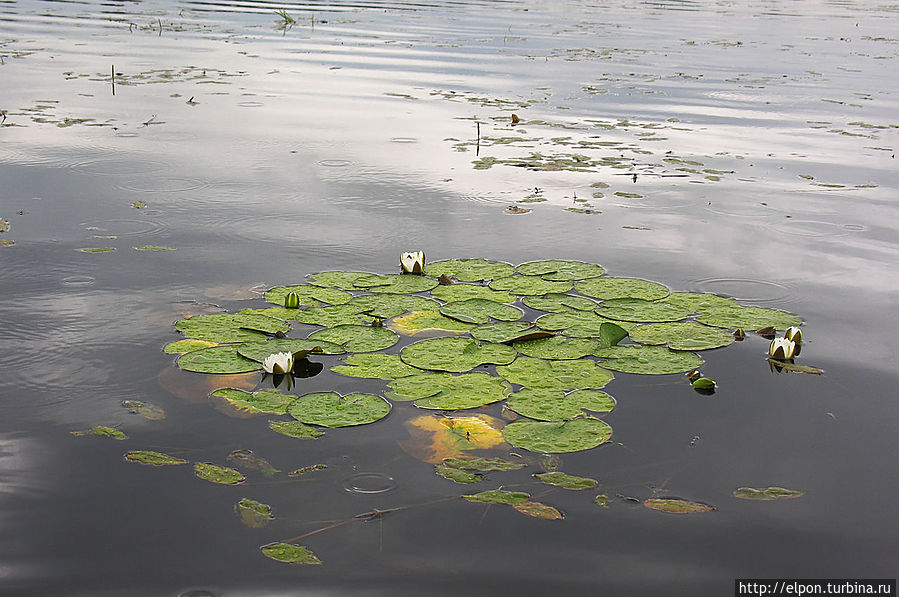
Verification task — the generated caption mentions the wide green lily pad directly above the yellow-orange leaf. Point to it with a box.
[387,371,512,410]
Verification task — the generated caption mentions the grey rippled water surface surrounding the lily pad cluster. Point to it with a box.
[0,1,899,597]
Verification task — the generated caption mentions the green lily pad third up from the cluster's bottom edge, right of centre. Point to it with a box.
[496,357,614,390]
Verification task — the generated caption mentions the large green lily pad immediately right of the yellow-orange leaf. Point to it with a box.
[503,417,612,454]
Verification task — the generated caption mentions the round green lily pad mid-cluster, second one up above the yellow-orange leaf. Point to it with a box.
[400,338,515,373]
